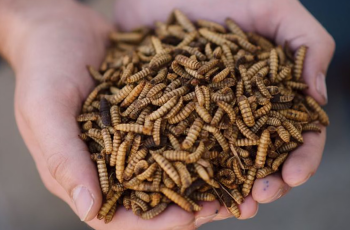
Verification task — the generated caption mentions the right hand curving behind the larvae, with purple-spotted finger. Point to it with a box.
[115,0,335,227]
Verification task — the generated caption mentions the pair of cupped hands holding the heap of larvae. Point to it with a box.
[0,0,335,230]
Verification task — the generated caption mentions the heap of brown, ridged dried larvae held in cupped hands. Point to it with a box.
[77,10,329,223]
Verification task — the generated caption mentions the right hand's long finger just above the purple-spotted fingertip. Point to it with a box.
[282,127,326,187]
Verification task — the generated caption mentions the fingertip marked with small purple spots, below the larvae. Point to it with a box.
[252,173,290,204]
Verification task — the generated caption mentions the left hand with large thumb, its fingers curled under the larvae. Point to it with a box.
[0,0,223,230]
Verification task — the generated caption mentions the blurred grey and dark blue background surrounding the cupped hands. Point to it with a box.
[0,0,350,230]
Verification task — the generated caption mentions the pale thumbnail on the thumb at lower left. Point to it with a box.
[73,185,94,221]
